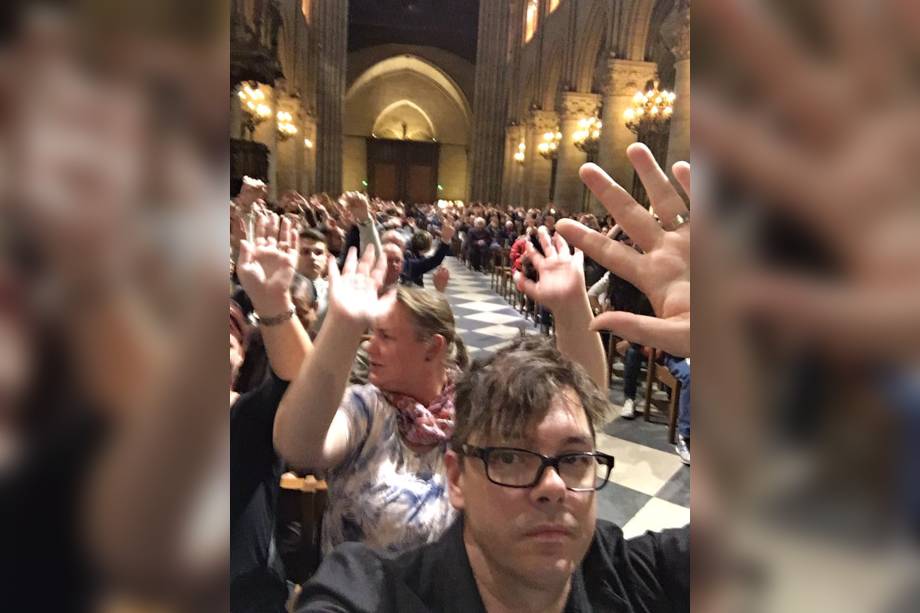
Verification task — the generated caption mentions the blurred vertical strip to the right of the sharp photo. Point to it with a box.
[692,0,920,611]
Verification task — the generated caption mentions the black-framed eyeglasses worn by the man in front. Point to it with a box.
[460,444,613,492]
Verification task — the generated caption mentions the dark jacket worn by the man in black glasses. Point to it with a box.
[297,520,690,613]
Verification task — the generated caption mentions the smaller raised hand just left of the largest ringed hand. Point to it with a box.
[514,228,585,313]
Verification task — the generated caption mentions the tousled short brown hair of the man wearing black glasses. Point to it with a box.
[451,335,609,450]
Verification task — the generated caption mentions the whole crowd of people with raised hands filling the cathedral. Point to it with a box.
[230,146,689,611]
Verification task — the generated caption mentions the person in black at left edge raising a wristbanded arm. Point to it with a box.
[230,216,313,613]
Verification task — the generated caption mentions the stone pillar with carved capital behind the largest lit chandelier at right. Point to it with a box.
[597,59,658,191]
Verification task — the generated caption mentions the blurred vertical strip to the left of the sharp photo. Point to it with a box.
[0,0,229,611]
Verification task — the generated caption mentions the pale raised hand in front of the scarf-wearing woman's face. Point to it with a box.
[329,245,387,326]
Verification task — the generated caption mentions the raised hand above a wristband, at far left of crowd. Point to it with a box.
[236,213,298,317]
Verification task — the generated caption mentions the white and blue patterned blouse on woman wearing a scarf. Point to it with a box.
[322,384,456,554]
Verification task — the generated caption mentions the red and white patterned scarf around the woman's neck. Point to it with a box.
[383,371,459,447]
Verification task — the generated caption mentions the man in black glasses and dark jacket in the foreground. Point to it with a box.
[298,336,689,613]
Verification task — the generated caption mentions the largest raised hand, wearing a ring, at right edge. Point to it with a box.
[556,143,690,356]
